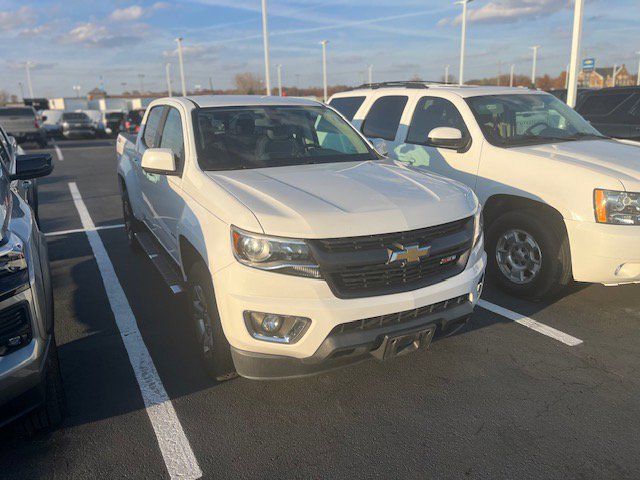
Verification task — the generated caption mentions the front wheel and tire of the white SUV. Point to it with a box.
[487,209,572,300]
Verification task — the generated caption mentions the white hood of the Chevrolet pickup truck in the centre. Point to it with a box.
[207,160,477,238]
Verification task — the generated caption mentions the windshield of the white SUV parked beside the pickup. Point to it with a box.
[467,94,607,147]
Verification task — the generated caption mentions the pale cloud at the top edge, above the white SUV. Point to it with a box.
[438,0,570,26]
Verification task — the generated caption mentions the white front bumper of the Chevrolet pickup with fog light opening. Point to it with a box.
[213,238,486,378]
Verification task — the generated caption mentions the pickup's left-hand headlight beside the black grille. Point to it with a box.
[231,227,321,278]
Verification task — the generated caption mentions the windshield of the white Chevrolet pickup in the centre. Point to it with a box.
[194,106,378,170]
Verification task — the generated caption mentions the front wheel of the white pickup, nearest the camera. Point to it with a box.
[188,262,238,382]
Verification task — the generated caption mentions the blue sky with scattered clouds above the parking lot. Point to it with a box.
[0,0,640,97]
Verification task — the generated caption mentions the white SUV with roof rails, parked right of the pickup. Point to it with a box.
[330,82,640,299]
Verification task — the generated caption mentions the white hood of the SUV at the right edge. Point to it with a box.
[513,140,640,190]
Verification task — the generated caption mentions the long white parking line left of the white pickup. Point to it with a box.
[69,182,202,479]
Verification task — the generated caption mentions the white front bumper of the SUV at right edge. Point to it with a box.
[565,220,640,285]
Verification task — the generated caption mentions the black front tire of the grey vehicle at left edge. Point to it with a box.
[16,338,66,436]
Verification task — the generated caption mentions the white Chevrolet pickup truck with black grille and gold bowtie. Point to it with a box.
[117,96,486,380]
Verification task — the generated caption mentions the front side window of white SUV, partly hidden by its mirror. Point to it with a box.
[407,97,469,145]
